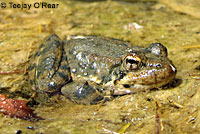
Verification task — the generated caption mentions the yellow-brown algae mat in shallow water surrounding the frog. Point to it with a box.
[0,0,200,134]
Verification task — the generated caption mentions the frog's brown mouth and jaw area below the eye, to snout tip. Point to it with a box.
[114,64,177,95]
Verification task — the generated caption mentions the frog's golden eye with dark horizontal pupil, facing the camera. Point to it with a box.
[124,54,141,71]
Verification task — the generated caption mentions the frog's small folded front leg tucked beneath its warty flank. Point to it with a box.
[61,81,111,104]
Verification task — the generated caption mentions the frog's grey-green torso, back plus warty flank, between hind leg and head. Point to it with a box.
[64,36,140,83]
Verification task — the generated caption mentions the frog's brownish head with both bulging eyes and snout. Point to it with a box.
[114,43,177,94]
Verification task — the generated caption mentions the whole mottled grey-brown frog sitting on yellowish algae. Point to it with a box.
[28,34,177,104]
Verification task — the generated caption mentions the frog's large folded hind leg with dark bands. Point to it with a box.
[28,36,71,92]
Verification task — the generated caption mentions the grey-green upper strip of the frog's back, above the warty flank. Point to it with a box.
[64,36,141,58]
